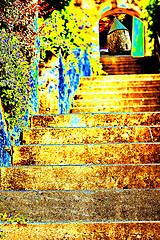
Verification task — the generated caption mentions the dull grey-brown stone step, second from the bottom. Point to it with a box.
[0,190,160,222]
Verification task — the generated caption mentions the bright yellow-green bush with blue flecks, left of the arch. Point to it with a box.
[38,7,101,74]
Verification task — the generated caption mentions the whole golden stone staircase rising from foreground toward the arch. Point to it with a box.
[0,74,160,240]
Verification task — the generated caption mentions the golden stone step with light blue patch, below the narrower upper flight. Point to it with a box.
[30,112,160,128]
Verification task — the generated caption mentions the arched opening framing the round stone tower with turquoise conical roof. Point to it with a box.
[99,13,133,57]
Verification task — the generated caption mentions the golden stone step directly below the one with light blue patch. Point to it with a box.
[21,126,160,144]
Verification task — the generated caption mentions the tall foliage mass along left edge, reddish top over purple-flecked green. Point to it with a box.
[0,0,41,139]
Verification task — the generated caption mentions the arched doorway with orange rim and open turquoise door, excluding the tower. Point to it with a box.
[99,8,144,57]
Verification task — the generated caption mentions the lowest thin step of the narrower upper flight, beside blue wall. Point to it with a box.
[69,104,160,114]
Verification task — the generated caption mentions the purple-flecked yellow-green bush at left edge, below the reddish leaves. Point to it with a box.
[0,30,31,137]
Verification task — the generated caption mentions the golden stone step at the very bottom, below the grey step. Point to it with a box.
[3,221,160,240]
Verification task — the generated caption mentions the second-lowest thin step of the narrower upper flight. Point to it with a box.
[73,97,160,107]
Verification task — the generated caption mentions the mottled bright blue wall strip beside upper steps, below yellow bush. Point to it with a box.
[58,49,91,114]
